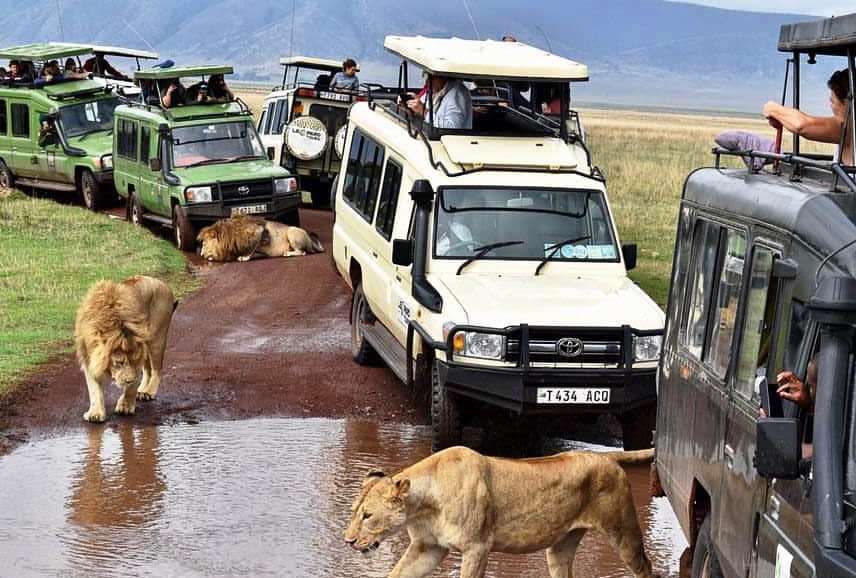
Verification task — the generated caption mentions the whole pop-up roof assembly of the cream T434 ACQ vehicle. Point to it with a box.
[380,36,603,180]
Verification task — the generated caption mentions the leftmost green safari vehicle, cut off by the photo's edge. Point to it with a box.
[0,44,119,210]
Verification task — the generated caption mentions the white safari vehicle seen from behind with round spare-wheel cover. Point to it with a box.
[258,56,359,206]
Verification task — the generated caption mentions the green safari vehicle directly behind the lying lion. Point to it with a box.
[113,66,300,251]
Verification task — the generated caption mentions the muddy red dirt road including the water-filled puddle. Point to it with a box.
[0,211,685,578]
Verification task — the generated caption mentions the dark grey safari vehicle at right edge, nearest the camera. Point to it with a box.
[655,14,856,578]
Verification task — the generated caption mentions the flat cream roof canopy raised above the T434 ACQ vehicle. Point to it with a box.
[383,36,588,82]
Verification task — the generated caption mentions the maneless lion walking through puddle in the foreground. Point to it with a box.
[345,447,653,578]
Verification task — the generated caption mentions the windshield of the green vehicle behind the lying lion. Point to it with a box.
[172,121,266,168]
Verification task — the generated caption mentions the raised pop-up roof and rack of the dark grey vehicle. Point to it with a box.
[714,14,856,192]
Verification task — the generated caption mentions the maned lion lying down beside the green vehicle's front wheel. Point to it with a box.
[196,215,324,261]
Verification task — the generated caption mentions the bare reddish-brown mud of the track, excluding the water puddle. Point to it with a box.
[0,210,425,454]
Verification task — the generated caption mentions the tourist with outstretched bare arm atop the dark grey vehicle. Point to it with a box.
[763,69,856,165]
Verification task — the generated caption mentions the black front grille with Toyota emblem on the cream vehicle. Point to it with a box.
[506,328,624,367]
